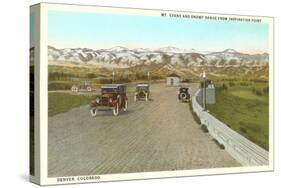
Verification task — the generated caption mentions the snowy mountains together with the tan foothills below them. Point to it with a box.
[45,46,269,80]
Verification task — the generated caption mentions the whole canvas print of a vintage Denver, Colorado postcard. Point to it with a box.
[30,3,274,185]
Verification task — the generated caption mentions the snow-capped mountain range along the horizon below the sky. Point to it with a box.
[48,46,269,68]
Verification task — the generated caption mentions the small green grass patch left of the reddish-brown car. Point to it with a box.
[48,93,94,116]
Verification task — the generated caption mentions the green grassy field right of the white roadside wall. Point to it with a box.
[208,82,269,150]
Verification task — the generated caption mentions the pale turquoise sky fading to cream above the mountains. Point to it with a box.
[48,11,269,53]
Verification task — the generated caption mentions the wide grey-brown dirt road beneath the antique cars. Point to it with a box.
[48,84,239,177]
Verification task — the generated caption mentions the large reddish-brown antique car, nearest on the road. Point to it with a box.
[90,84,128,117]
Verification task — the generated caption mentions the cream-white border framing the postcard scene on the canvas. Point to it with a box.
[37,3,274,185]
